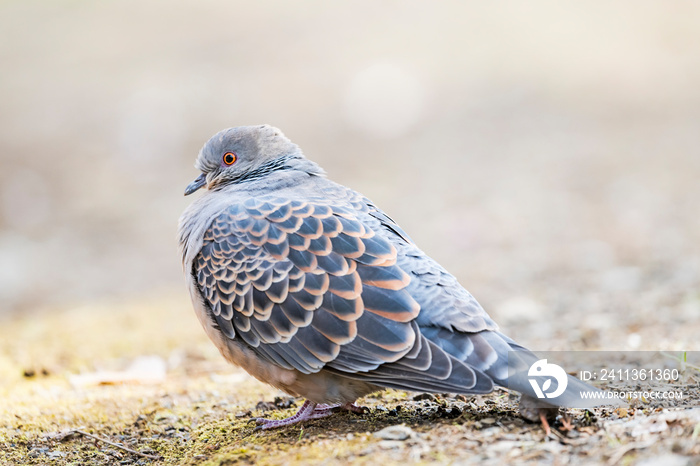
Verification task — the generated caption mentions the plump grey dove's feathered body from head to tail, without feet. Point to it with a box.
[179,125,604,430]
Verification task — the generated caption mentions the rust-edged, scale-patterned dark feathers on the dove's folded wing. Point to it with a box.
[193,197,420,373]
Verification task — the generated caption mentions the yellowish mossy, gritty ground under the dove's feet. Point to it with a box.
[0,297,700,465]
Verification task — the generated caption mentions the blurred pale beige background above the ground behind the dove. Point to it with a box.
[0,0,700,350]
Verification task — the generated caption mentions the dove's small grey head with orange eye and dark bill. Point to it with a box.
[185,125,303,196]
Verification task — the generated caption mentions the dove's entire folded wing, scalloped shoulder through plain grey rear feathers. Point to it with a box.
[193,190,503,393]
